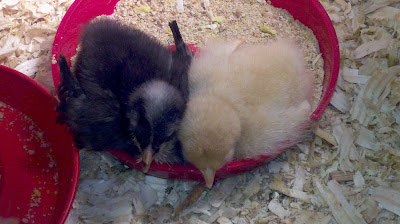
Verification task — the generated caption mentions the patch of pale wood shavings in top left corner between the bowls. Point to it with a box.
[0,0,73,93]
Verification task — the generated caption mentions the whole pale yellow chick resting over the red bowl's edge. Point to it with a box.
[179,39,314,188]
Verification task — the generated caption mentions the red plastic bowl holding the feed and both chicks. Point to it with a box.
[52,0,340,180]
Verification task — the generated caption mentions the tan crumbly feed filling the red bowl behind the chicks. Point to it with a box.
[110,0,324,108]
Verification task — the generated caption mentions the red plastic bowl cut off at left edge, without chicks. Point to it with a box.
[0,65,79,224]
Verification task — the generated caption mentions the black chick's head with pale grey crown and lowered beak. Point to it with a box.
[127,80,186,172]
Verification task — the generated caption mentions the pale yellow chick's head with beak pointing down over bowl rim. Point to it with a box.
[179,94,241,188]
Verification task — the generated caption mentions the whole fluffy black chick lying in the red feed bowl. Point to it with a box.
[58,18,191,168]
